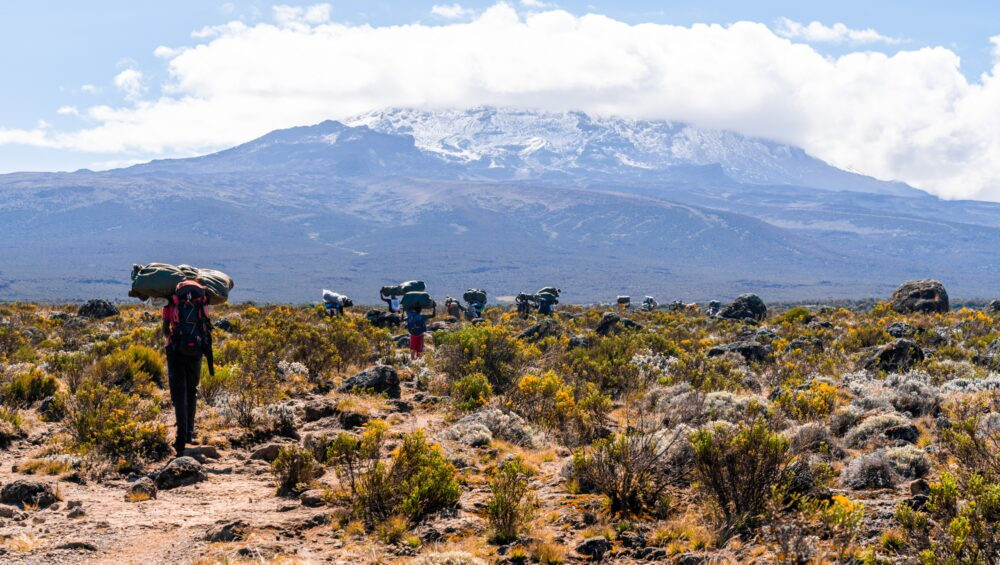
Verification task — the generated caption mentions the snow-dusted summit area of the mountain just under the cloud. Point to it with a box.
[344,107,918,196]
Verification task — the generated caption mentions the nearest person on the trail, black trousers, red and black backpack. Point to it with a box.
[163,280,215,457]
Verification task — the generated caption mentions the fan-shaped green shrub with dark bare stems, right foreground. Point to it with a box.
[690,420,789,533]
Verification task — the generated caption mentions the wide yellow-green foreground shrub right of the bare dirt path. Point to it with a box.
[327,420,461,525]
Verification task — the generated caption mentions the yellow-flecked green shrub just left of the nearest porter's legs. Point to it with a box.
[67,380,168,470]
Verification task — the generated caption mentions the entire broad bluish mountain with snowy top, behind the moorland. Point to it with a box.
[0,109,1000,303]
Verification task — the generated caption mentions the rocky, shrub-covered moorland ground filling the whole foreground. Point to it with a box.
[0,281,1000,565]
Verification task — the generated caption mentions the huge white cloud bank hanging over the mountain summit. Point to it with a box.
[9,3,1000,200]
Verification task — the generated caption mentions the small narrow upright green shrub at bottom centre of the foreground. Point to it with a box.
[486,457,537,544]
